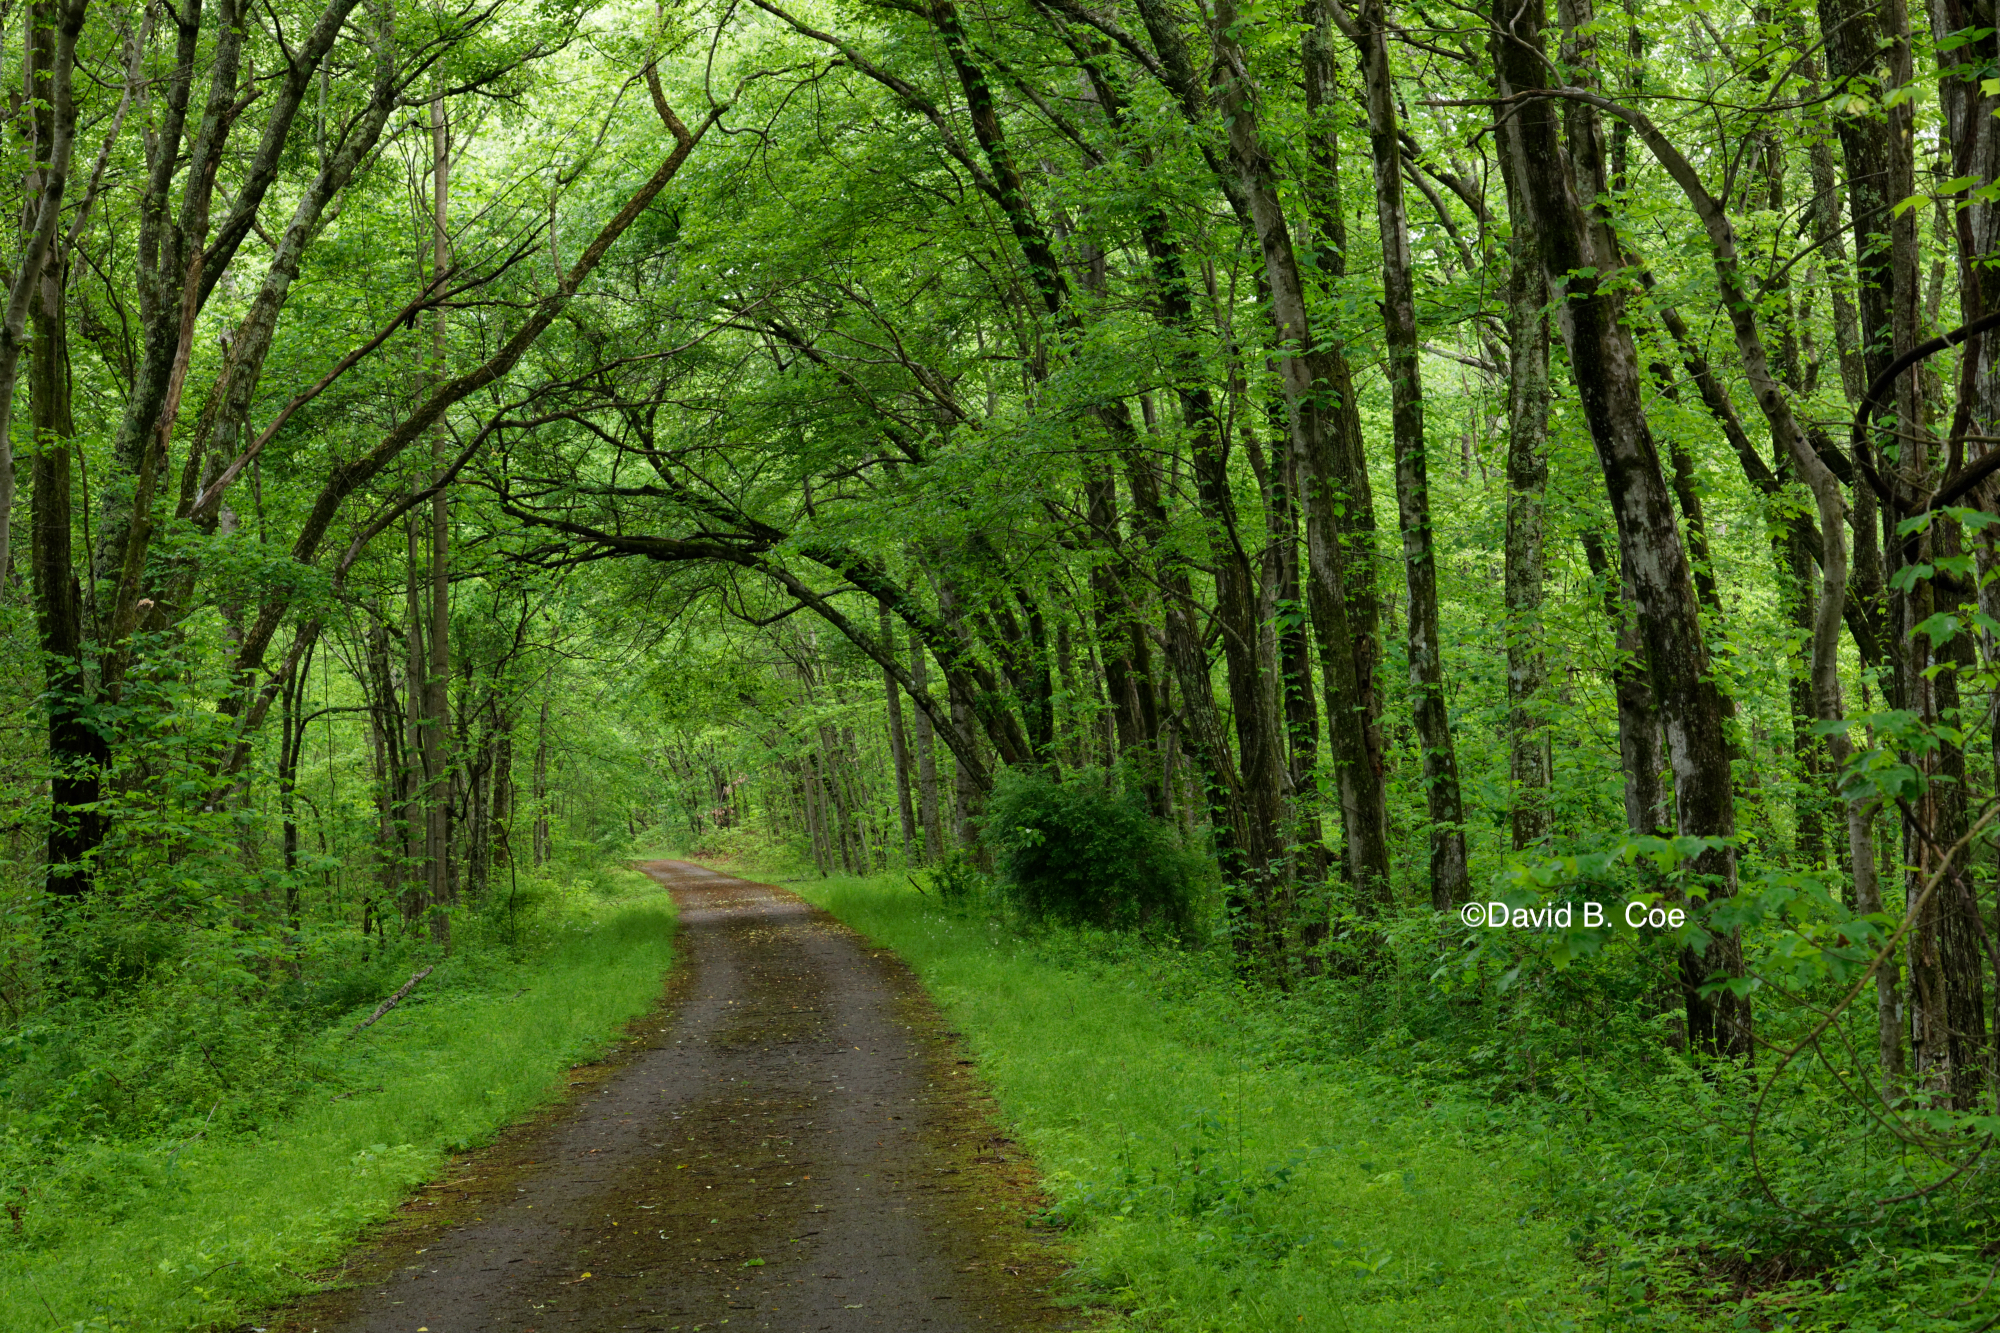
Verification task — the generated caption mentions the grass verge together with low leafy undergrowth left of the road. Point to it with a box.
[0,863,672,1333]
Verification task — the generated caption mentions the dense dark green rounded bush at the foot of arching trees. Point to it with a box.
[986,769,1206,931]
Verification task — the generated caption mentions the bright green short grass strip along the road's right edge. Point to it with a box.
[794,875,1616,1333]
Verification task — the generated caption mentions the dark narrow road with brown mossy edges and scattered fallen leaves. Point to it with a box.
[270,861,1080,1333]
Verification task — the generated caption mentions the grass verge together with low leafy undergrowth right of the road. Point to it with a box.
[780,875,2000,1333]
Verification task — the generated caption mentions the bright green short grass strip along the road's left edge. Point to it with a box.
[0,893,674,1333]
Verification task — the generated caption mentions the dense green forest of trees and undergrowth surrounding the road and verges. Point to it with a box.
[0,0,2000,1333]
